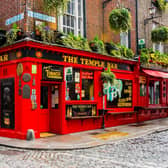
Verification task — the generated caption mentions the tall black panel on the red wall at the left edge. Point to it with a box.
[0,78,15,129]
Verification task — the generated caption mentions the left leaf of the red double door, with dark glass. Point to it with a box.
[39,86,50,132]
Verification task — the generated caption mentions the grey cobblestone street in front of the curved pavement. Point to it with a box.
[0,131,168,168]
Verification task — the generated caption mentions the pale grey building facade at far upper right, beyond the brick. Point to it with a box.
[138,0,168,53]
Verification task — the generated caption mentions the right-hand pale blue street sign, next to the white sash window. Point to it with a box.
[27,11,56,23]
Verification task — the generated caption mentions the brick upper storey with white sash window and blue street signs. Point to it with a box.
[0,0,136,52]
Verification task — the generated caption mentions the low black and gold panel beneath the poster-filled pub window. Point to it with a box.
[66,104,96,117]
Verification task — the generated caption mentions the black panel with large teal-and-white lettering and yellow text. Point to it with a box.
[107,79,132,108]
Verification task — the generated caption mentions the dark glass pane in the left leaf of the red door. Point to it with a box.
[40,86,48,109]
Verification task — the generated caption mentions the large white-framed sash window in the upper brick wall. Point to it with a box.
[59,0,83,36]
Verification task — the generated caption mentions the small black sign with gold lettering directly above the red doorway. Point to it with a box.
[42,64,63,81]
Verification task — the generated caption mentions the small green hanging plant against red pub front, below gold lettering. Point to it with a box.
[101,68,115,84]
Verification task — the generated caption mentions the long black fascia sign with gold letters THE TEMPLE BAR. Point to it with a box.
[2,48,134,71]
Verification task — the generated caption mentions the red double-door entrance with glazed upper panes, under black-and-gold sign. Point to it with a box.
[39,84,60,133]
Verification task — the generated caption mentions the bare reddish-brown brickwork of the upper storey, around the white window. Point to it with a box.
[0,0,136,52]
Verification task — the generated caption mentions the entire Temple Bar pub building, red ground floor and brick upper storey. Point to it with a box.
[0,0,168,139]
